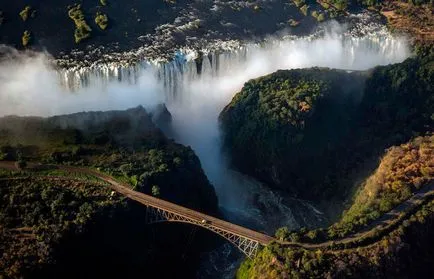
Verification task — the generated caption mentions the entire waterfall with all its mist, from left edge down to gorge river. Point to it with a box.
[0,24,409,233]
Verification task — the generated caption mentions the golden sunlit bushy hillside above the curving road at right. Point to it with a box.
[329,135,434,237]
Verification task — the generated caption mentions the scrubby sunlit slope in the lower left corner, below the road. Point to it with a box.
[0,176,124,278]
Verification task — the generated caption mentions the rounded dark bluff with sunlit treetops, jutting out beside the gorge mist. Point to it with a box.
[220,68,364,200]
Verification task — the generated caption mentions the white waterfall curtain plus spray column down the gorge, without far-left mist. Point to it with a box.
[53,24,408,232]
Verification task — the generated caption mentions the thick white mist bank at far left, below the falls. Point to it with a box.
[0,47,164,116]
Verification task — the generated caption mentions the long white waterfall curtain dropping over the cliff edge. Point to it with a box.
[58,30,408,102]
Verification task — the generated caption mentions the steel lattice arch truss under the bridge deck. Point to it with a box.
[146,205,259,259]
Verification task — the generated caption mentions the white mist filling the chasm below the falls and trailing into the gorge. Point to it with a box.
[0,25,409,220]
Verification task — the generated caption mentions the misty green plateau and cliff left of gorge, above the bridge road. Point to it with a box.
[0,107,217,212]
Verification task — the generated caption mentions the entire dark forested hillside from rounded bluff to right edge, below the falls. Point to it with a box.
[220,51,434,203]
